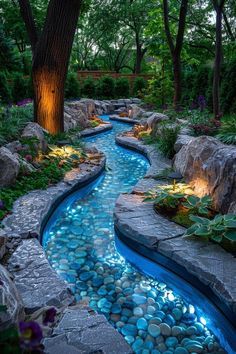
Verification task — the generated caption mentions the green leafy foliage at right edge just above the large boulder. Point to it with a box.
[216,116,236,145]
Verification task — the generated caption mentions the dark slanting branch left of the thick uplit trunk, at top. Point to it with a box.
[18,0,38,52]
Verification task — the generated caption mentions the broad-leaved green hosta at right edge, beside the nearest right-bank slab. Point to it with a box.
[186,214,236,243]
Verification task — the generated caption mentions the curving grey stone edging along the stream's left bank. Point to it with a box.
[3,153,106,313]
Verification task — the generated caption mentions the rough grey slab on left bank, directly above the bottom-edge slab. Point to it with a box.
[7,239,73,313]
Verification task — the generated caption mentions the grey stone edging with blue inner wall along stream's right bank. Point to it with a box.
[114,135,236,326]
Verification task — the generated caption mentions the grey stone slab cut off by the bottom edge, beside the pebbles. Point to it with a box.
[43,308,132,354]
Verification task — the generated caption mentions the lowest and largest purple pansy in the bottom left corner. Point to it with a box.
[19,321,43,349]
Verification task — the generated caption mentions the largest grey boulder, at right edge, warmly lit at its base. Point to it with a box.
[174,136,236,213]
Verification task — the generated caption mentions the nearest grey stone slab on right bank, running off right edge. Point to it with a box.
[158,237,236,312]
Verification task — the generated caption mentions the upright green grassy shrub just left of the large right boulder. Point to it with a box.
[157,124,180,158]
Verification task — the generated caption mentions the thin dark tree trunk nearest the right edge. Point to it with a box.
[213,0,226,119]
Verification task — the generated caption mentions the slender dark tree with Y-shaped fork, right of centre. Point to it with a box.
[163,0,188,108]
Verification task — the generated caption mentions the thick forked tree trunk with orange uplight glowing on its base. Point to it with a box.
[18,0,83,134]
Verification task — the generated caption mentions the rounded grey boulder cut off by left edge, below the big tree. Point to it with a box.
[0,147,20,187]
